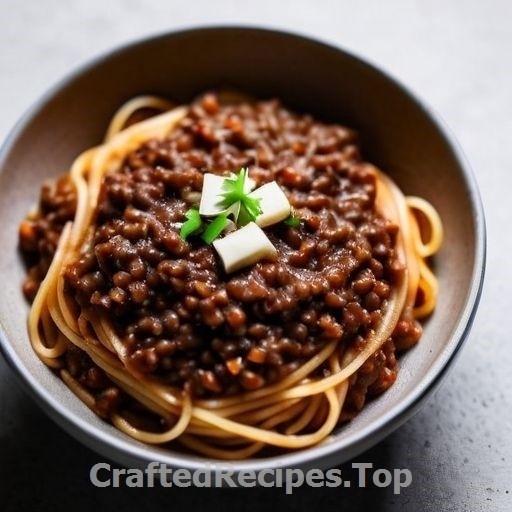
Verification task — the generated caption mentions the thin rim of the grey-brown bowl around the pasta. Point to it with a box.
[0,24,486,472]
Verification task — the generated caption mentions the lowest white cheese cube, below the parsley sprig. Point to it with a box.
[213,222,277,273]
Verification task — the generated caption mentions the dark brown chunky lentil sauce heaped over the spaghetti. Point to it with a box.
[20,94,421,420]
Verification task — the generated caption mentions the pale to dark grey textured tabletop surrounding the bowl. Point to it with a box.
[0,0,512,512]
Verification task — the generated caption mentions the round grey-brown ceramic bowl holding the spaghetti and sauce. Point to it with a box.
[0,27,485,472]
